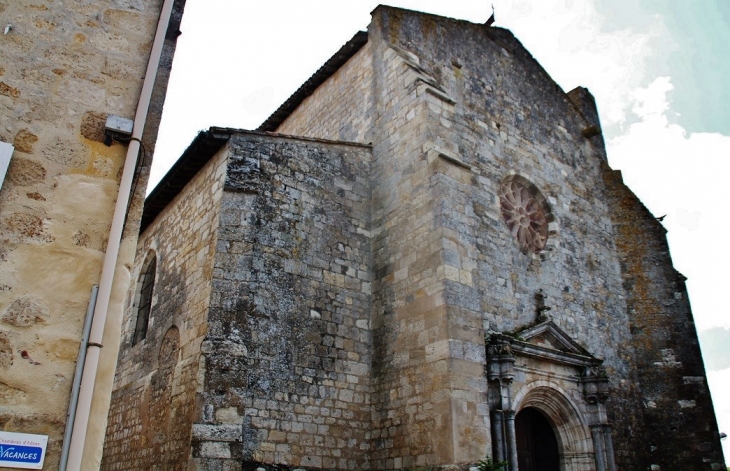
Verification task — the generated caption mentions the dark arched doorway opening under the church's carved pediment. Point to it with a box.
[515,407,560,471]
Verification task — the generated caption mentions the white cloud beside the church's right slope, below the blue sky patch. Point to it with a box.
[607,77,730,329]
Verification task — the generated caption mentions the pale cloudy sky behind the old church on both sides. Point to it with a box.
[150,0,730,457]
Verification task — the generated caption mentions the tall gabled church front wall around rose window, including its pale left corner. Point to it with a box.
[270,8,664,469]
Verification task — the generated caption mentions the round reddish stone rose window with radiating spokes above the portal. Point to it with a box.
[499,176,549,254]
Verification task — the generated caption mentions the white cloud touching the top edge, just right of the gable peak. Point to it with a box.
[498,0,665,135]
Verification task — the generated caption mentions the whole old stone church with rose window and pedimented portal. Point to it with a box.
[102,6,725,471]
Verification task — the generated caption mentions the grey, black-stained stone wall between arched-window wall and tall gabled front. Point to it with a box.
[193,134,372,470]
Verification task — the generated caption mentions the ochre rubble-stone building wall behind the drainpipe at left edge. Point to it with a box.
[0,0,184,469]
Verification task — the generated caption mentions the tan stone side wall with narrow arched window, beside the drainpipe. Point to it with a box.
[101,149,227,470]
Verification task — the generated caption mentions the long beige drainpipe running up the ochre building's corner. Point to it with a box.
[66,0,174,471]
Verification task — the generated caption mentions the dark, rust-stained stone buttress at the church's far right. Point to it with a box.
[604,167,725,470]
